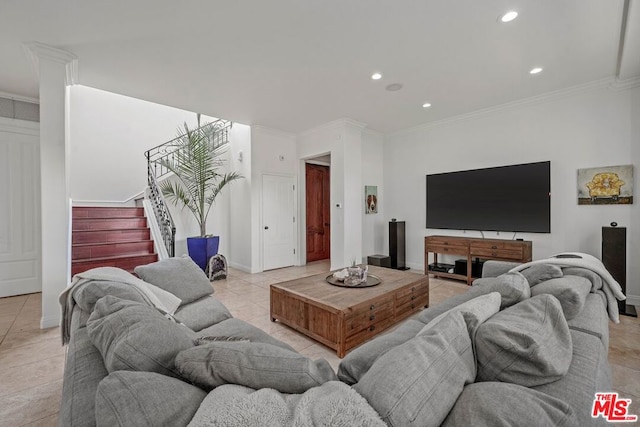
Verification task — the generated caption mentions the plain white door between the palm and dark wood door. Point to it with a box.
[262,174,296,270]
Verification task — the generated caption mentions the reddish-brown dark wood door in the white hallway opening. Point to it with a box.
[306,164,331,262]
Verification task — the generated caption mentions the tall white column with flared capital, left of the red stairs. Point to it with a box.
[25,43,77,329]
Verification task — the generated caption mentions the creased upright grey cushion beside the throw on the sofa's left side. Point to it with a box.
[87,296,196,376]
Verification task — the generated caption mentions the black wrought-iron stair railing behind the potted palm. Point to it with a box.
[144,119,233,257]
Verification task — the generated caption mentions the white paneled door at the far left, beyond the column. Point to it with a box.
[0,125,41,297]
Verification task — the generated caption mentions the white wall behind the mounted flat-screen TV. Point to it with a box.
[383,83,640,302]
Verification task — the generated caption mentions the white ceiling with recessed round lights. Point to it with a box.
[0,0,640,133]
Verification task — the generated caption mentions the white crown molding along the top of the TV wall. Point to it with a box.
[387,77,626,137]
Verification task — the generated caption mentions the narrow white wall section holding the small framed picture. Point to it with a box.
[360,130,388,262]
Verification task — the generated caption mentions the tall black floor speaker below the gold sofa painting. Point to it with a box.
[602,227,638,317]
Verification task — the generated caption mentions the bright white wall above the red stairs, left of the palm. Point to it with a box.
[69,85,215,204]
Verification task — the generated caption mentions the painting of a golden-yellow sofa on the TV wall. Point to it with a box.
[578,165,633,205]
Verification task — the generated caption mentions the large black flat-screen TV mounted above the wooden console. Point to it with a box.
[427,162,551,233]
